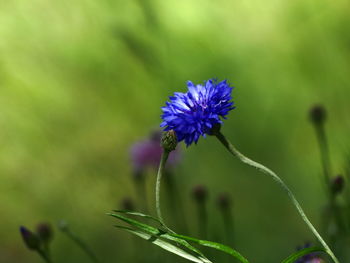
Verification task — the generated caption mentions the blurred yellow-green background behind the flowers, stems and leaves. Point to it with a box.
[0,0,350,263]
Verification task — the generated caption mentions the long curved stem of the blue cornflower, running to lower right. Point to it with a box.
[215,132,339,263]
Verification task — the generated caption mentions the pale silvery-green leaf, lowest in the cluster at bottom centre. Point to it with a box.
[116,226,211,263]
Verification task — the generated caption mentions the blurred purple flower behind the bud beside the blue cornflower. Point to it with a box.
[130,131,180,174]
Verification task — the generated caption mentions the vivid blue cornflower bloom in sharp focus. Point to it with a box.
[160,79,235,146]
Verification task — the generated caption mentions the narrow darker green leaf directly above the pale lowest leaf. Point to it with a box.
[108,212,211,263]
